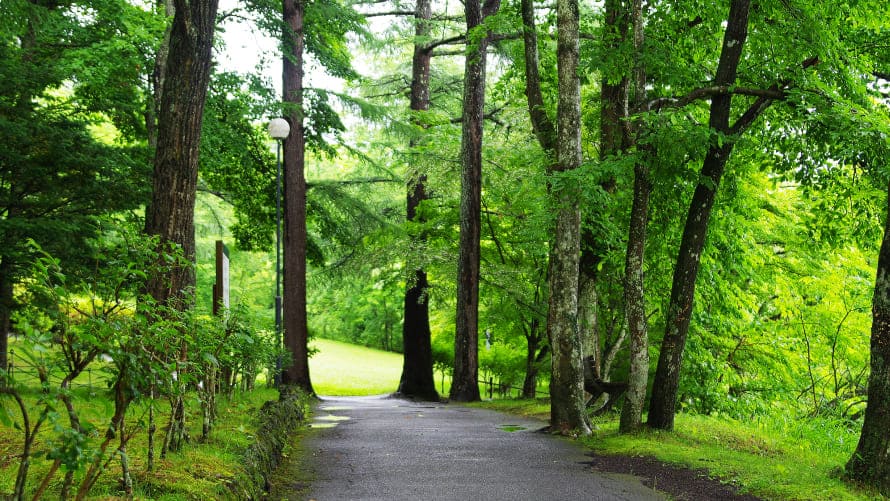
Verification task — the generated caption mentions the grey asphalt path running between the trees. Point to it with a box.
[304,397,664,501]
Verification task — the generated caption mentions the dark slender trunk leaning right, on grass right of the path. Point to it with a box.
[648,0,751,430]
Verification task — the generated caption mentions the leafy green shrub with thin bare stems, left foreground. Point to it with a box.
[3,228,284,492]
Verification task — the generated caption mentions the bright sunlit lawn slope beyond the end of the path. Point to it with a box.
[309,338,402,396]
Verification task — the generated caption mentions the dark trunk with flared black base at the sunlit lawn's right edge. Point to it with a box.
[398,0,439,401]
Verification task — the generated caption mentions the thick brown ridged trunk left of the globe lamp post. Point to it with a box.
[145,0,218,308]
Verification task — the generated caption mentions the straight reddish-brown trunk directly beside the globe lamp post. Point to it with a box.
[281,0,315,395]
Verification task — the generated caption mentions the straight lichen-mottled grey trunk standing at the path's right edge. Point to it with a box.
[547,0,590,435]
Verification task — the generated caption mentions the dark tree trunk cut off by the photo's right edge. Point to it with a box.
[847,182,890,496]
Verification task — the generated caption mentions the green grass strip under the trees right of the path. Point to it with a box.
[472,399,885,500]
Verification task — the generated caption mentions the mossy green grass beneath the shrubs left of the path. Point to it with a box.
[0,387,278,500]
